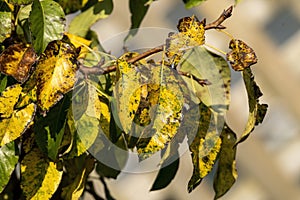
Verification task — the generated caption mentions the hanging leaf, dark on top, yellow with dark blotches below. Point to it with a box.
[188,104,222,192]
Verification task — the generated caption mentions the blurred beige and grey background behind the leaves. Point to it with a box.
[80,0,300,200]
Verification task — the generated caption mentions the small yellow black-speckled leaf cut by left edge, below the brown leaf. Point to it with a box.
[0,84,22,118]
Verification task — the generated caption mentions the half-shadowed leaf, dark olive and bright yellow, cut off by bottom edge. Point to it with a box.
[21,148,63,200]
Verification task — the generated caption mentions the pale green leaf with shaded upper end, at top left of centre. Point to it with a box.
[68,0,113,37]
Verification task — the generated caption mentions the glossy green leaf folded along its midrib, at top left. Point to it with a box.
[29,0,65,54]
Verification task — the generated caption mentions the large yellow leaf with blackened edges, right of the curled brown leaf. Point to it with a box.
[30,41,78,115]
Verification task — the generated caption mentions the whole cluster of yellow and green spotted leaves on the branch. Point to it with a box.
[0,0,267,199]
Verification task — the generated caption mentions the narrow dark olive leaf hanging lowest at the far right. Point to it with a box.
[214,125,238,199]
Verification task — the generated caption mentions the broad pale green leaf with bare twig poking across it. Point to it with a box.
[180,46,231,115]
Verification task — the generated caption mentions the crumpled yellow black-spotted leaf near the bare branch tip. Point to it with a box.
[166,15,205,64]
